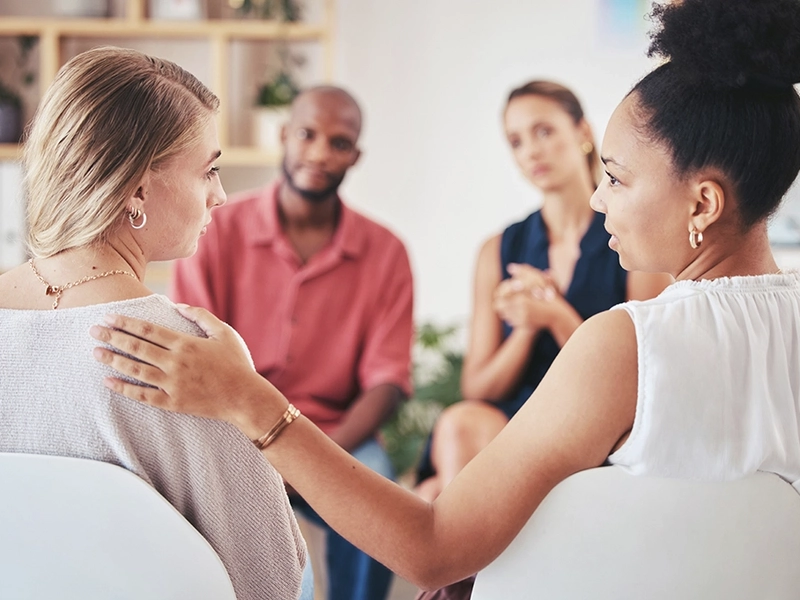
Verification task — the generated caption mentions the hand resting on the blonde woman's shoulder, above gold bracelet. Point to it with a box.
[89,307,287,438]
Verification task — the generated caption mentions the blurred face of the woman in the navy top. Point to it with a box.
[503,95,590,192]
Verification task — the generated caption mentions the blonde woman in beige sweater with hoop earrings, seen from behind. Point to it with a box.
[0,48,306,600]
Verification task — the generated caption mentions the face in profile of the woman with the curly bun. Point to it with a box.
[591,96,693,275]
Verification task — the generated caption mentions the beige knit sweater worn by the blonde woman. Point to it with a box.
[0,295,306,600]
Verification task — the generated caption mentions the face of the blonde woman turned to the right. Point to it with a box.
[141,116,227,260]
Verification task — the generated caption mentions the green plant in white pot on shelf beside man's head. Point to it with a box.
[255,48,302,152]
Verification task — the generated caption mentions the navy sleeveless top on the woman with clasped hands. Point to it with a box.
[495,211,628,418]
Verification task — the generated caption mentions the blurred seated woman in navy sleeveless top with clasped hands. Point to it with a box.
[417,81,671,500]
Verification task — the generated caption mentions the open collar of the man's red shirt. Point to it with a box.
[248,179,366,258]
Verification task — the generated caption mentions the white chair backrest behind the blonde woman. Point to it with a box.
[0,453,236,600]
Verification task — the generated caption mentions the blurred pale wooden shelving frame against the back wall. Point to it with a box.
[0,0,334,166]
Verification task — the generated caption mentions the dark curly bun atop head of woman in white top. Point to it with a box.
[648,0,800,89]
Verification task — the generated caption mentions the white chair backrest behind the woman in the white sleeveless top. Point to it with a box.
[472,467,800,600]
